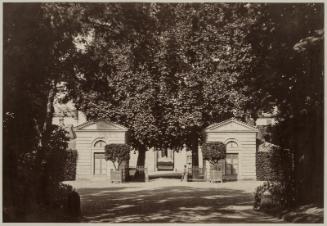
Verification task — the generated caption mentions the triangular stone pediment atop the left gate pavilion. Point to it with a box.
[75,120,128,132]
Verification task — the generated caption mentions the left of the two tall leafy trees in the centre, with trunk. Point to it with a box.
[67,4,168,165]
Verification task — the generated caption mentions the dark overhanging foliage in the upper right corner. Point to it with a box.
[240,4,323,115]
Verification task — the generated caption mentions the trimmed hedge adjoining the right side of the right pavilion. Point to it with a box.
[256,146,293,181]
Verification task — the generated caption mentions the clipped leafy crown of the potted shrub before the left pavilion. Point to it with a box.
[105,144,131,169]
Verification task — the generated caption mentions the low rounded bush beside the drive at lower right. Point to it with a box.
[254,181,295,212]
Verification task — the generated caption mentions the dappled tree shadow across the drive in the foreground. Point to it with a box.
[78,186,282,223]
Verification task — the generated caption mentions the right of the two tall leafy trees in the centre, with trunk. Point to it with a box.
[164,4,254,163]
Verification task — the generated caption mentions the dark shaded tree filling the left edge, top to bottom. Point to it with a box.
[3,3,79,220]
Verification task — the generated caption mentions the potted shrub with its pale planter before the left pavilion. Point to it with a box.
[105,144,131,182]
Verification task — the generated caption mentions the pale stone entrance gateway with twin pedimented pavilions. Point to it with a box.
[74,118,258,180]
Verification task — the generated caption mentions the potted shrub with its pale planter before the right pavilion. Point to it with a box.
[202,142,226,182]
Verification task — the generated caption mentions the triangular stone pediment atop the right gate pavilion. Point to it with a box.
[205,118,258,132]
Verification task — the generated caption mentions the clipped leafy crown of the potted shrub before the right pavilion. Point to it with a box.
[202,142,226,165]
